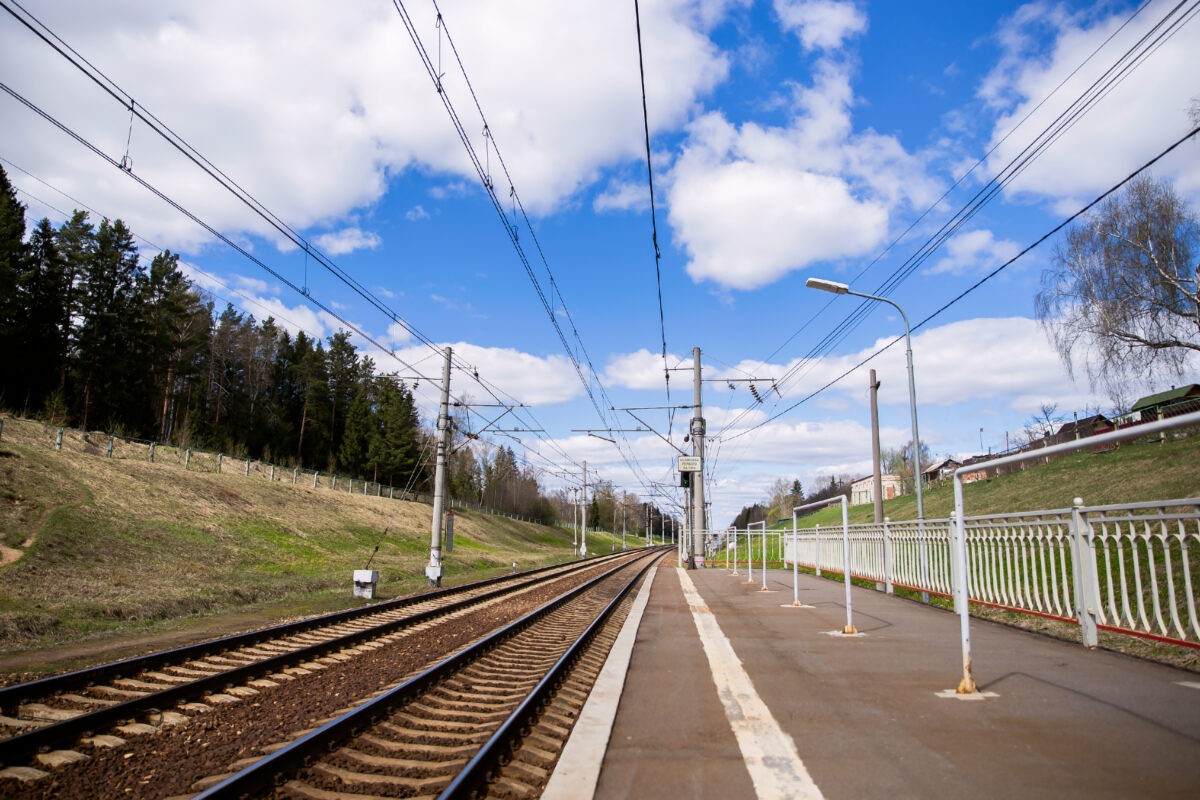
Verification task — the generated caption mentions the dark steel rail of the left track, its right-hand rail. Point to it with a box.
[0,554,633,765]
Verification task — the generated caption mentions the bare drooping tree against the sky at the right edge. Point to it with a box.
[1036,178,1200,393]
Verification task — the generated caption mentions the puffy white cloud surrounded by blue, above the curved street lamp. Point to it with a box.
[668,61,936,289]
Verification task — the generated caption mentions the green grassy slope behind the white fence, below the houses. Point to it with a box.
[776,435,1200,528]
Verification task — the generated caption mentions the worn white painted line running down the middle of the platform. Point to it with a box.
[679,570,824,800]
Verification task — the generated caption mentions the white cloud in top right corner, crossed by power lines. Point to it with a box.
[978,2,1200,212]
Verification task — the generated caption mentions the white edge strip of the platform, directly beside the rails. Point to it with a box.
[541,567,658,800]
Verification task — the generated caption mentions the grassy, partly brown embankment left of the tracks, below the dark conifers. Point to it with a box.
[0,419,641,670]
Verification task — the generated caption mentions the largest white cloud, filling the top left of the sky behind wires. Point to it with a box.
[0,0,740,252]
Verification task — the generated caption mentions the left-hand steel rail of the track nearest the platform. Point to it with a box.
[193,547,664,800]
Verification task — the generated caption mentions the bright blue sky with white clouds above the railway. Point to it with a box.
[0,0,1200,528]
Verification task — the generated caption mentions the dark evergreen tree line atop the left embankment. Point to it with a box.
[0,169,558,523]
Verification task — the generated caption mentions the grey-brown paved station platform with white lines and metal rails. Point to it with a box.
[545,560,1200,800]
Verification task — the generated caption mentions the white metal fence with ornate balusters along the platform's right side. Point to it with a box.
[781,498,1200,646]
